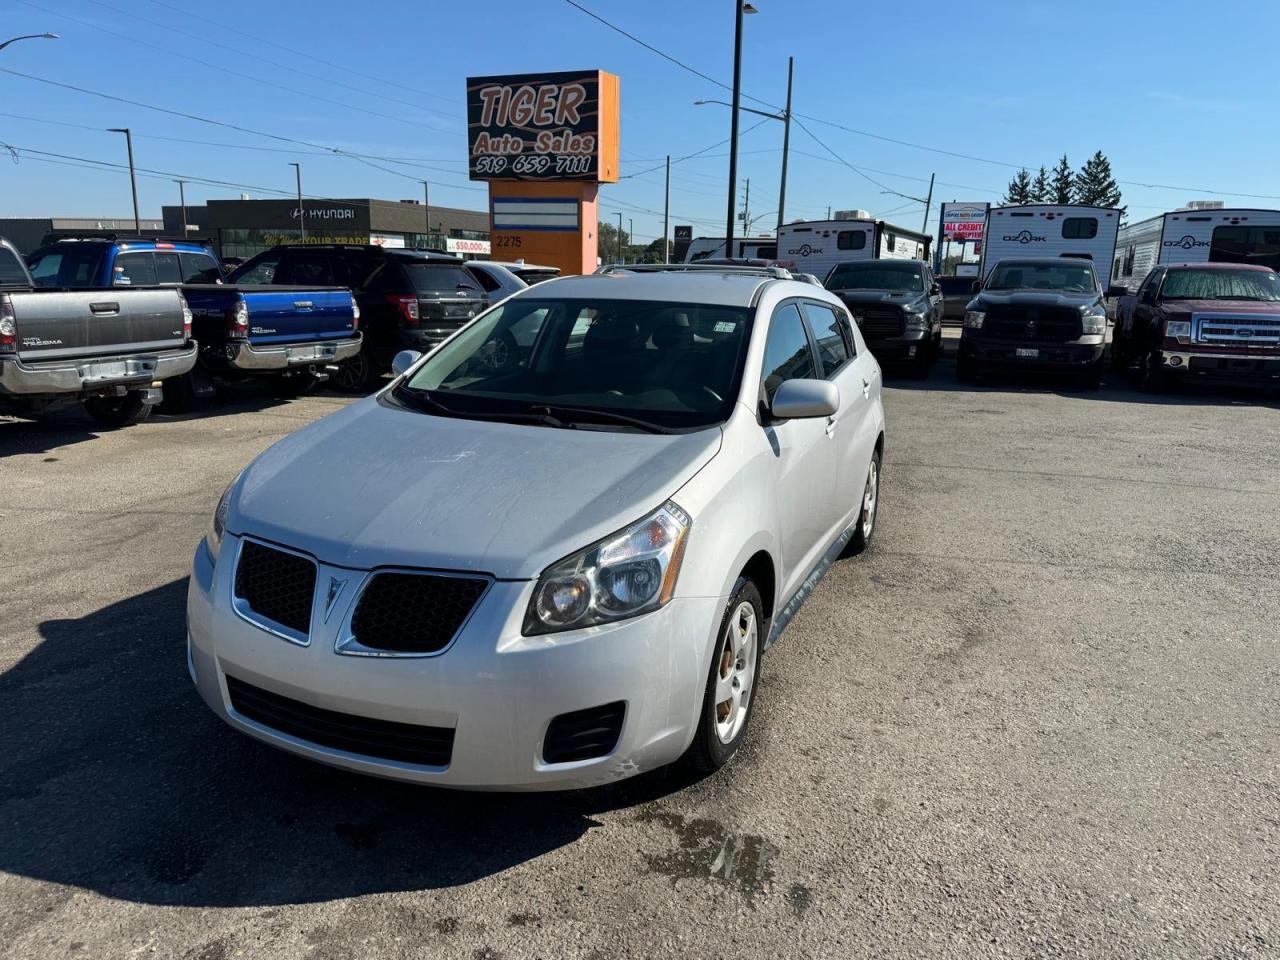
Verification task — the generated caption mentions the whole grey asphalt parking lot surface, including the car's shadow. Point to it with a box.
[0,362,1280,960]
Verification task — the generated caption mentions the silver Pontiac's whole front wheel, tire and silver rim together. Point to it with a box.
[685,577,767,773]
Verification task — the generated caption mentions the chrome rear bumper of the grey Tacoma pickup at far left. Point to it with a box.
[0,343,197,397]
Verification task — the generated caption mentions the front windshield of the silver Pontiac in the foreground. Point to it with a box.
[401,294,751,429]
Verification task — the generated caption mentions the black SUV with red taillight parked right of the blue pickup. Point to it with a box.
[230,244,488,393]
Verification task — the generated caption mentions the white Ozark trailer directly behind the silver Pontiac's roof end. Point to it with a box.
[778,211,932,279]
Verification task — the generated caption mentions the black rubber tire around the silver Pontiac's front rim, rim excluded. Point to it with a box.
[682,577,769,773]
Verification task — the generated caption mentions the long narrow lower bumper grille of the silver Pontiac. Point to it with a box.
[227,675,454,767]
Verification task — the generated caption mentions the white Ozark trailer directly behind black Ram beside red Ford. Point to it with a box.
[982,204,1120,285]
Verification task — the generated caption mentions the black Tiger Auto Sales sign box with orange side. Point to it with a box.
[467,70,618,183]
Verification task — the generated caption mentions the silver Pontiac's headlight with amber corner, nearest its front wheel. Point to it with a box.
[524,500,692,636]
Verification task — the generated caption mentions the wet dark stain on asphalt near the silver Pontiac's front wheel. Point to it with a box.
[640,812,778,899]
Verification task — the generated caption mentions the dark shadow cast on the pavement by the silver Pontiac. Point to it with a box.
[0,579,694,906]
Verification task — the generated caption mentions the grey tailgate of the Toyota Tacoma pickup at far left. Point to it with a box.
[8,288,186,362]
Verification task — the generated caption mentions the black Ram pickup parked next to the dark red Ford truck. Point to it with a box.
[956,257,1107,387]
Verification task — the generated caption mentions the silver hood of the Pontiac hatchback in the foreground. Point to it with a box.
[227,397,721,580]
